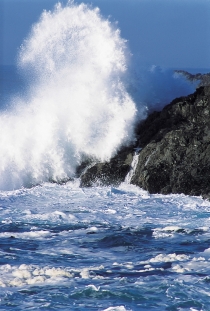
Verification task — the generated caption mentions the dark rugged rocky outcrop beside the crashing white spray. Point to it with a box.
[80,73,210,199]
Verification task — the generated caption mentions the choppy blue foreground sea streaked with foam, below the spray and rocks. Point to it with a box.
[0,181,210,311]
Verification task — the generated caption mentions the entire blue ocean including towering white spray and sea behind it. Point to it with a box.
[0,3,210,311]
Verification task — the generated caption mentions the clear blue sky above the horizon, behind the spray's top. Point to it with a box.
[0,0,210,68]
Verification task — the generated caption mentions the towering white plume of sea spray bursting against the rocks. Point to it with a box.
[0,2,136,190]
